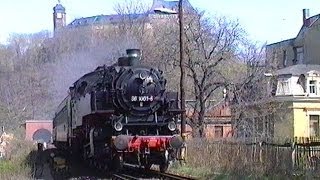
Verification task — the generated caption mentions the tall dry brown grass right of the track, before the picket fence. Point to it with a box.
[169,139,302,180]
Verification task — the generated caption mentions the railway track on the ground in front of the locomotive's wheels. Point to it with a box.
[112,165,194,180]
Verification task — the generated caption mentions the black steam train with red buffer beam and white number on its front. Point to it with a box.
[53,49,182,171]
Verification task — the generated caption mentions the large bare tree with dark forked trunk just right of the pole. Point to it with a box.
[182,13,243,137]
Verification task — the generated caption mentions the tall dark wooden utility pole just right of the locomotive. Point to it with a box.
[179,0,186,141]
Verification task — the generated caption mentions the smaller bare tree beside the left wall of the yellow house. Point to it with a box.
[228,44,282,140]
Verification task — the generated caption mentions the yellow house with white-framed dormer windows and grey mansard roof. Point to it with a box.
[274,64,320,138]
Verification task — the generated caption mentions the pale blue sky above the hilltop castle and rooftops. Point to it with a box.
[0,0,320,43]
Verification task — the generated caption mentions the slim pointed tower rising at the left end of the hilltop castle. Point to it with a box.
[53,2,66,33]
